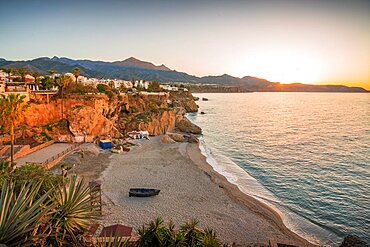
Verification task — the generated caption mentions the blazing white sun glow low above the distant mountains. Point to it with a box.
[248,50,321,84]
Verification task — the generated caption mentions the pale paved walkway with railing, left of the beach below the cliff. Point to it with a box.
[15,143,75,167]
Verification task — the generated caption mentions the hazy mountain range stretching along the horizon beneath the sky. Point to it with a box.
[0,57,367,92]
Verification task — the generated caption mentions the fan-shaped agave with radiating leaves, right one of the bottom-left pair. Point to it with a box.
[51,176,97,245]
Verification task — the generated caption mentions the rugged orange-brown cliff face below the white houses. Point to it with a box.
[25,92,201,142]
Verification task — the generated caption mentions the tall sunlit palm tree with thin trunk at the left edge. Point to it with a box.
[0,94,28,166]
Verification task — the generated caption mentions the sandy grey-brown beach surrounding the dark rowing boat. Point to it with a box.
[76,136,313,246]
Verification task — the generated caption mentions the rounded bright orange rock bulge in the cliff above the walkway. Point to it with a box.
[68,106,113,142]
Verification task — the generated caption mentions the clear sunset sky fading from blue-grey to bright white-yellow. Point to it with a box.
[0,0,370,89]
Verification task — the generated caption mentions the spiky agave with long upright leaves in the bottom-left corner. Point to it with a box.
[0,180,52,247]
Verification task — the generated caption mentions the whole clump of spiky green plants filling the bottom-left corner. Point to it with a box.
[0,165,97,246]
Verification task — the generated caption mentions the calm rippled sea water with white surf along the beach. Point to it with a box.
[188,93,370,246]
